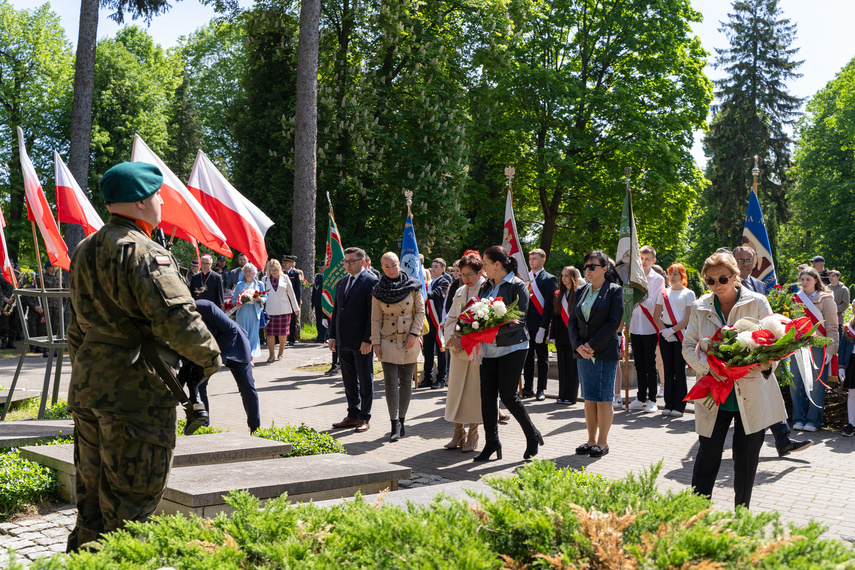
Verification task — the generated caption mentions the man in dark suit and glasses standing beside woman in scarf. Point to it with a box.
[328,247,377,432]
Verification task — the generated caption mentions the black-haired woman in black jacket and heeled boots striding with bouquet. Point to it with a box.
[474,245,543,461]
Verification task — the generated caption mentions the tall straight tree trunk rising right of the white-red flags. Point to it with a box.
[291,0,321,322]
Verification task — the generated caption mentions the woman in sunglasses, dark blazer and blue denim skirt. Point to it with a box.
[568,250,623,457]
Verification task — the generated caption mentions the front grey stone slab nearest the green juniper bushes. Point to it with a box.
[158,453,412,517]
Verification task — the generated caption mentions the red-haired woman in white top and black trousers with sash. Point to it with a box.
[653,263,695,418]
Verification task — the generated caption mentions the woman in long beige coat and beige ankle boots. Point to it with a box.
[443,252,484,451]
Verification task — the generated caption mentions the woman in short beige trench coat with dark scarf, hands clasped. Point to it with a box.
[371,251,425,442]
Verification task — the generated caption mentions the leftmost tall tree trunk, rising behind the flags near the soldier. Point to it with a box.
[65,0,98,254]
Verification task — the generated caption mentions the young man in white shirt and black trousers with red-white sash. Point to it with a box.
[629,245,665,413]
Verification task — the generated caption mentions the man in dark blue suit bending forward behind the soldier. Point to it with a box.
[196,300,261,433]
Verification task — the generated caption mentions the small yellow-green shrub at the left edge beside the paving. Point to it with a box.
[0,449,58,520]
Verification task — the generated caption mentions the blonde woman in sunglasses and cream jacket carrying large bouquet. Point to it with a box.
[683,251,787,508]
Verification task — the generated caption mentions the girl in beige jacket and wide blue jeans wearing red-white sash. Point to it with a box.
[790,267,840,431]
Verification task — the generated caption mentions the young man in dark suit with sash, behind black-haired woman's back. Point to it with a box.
[523,249,558,400]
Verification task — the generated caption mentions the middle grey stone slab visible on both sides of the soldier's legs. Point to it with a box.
[21,432,291,503]
